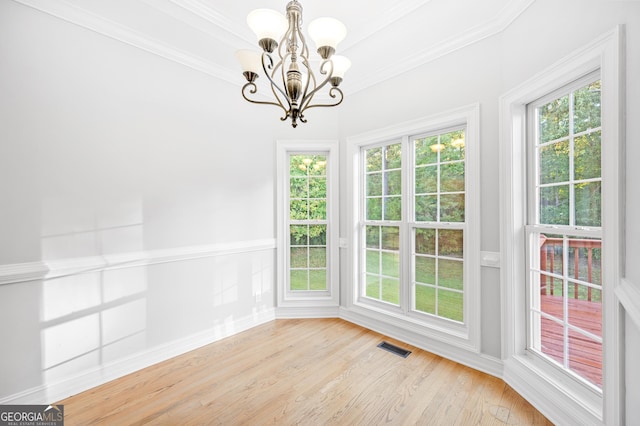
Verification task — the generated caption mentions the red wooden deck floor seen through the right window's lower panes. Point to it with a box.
[540,295,602,387]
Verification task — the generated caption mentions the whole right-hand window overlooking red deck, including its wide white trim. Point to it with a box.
[500,28,624,424]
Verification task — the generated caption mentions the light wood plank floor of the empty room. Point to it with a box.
[59,319,551,426]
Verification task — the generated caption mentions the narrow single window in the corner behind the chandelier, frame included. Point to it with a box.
[277,141,339,316]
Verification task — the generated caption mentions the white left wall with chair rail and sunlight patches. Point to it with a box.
[0,0,336,403]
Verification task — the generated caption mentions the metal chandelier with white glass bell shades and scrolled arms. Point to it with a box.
[236,0,351,127]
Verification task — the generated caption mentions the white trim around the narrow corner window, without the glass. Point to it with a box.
[276,140,340,312]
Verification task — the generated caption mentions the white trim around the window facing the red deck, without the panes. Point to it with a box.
[500,27,624,424]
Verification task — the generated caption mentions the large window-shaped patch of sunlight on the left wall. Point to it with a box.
[40,200,147,383]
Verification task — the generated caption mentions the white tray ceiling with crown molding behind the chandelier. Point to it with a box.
[15,0,535,93]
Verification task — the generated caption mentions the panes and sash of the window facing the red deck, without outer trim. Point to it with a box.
[526,75,606,388]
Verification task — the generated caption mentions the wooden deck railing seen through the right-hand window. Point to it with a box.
[540,235,602,301]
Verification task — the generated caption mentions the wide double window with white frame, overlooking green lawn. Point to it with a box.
[350,106,479,350]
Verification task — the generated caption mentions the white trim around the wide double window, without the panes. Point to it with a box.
[342,104,480,352]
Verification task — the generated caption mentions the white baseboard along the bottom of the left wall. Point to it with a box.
[0,308,276,405]
